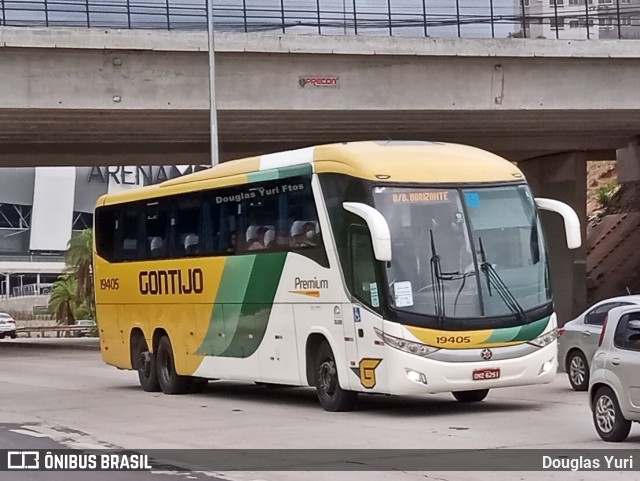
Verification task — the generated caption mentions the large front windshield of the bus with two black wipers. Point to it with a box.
[373,185,551,319]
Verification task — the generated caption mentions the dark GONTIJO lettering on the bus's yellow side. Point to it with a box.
[138,268,204,296]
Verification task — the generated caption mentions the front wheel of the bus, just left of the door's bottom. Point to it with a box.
[315,342,358,412]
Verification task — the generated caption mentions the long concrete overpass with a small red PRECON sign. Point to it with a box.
[0,27,640,166]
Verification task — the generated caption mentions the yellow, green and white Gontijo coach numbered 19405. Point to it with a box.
[94,141,581,411]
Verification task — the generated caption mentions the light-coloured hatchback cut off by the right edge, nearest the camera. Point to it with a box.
[589,306,640,442]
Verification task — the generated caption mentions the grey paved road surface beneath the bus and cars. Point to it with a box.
[0,341,640,481]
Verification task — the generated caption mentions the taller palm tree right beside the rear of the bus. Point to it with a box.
[64,229,95,316]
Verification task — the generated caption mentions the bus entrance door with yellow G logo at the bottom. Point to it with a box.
[342,226,387,392]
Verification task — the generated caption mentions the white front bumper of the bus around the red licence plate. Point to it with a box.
[387,341,558,394]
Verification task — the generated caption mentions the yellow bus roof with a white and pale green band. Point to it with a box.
[98,141,524,205]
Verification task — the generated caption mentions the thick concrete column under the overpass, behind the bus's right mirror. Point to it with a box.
[518,152,587,325]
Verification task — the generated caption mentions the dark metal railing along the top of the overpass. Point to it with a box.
[0,0,640,39]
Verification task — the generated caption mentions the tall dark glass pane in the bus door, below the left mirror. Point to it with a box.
[349,226,380,310]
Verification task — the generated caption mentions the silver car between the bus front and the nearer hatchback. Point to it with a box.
[558,295,640,391]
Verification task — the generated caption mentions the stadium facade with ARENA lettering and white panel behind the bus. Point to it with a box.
[0,166,206,297]
